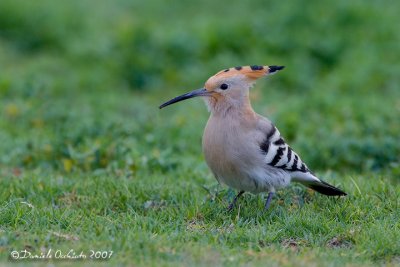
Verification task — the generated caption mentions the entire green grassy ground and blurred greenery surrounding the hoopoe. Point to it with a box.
[0,0,400,266]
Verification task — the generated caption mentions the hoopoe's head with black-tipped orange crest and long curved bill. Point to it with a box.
[160,66,284,114]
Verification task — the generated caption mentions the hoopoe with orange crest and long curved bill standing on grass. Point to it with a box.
[159,66,346,210]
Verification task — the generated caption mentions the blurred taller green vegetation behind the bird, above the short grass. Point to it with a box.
[0,0,400,175]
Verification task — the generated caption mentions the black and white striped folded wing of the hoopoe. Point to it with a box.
[260,126,310,173]
